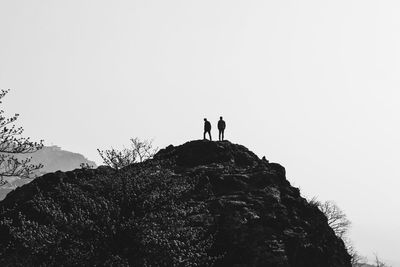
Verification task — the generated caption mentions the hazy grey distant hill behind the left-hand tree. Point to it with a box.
[0,146,96,200]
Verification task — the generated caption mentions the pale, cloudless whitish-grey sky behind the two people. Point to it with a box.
[0,0,400,261]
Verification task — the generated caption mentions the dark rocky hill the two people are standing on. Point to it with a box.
[0,141,351,267]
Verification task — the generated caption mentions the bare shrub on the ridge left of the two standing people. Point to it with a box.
[97,138,158,170]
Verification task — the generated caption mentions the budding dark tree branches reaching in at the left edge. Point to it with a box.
[0,90,43,184]
